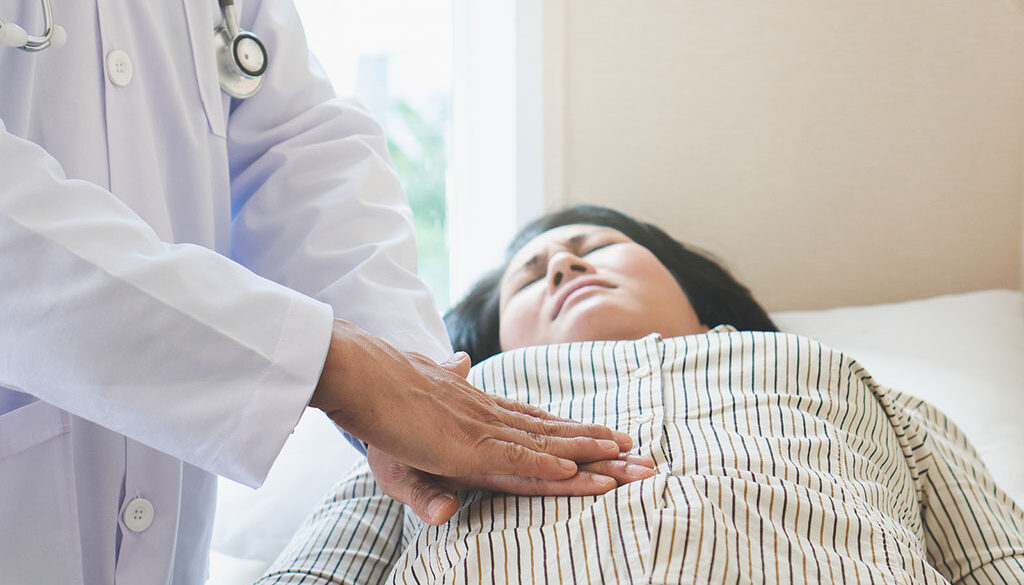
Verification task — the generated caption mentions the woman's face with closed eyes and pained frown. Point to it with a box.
[500,224,708,351]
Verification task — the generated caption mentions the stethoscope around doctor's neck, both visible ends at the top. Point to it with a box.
[0,0,269,98]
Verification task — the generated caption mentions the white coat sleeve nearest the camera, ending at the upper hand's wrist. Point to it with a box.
[0,121,331,486]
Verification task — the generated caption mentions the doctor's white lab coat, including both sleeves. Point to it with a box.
[0,0,450,585]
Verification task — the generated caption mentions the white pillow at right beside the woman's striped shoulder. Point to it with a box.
[772,290,1024,504]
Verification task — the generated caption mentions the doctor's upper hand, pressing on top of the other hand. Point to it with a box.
[309,321,632,489]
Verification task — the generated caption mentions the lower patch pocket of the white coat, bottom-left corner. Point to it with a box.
[0,401,82,583]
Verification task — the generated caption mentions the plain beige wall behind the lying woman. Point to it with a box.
[545,0,1024,309]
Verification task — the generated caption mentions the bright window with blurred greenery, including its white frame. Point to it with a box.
[296,0,563,310]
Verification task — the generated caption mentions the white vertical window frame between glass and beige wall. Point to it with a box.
[447,0,565,302]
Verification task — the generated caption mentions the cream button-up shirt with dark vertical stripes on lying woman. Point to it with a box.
[259,327,1024,585]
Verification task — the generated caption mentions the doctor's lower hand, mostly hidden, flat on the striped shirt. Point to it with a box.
[367,445,654,526]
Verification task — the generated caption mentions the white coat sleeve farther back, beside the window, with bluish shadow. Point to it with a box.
[227,0,452,361]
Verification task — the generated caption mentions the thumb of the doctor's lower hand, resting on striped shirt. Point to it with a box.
[367,448,459,526]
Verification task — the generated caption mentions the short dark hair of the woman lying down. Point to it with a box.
[444,205,778,364]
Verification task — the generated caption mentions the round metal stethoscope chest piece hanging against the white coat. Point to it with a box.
[213,0,267,99]
